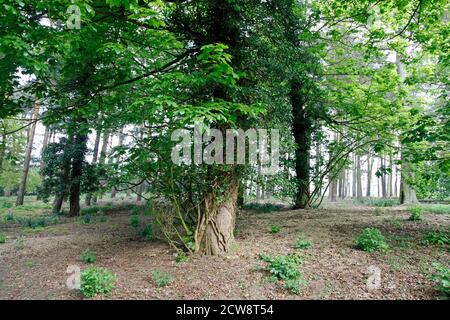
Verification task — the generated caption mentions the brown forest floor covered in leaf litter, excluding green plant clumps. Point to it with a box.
[0,198,450,299]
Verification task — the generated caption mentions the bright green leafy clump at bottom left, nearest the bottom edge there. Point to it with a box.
[80,267,117,298]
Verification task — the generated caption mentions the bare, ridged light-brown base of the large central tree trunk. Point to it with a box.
[195,181,239,255]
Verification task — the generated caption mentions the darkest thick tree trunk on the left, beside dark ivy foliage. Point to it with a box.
[69,134,87,217]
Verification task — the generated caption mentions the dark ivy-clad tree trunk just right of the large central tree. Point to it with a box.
[290,81,312,209]
